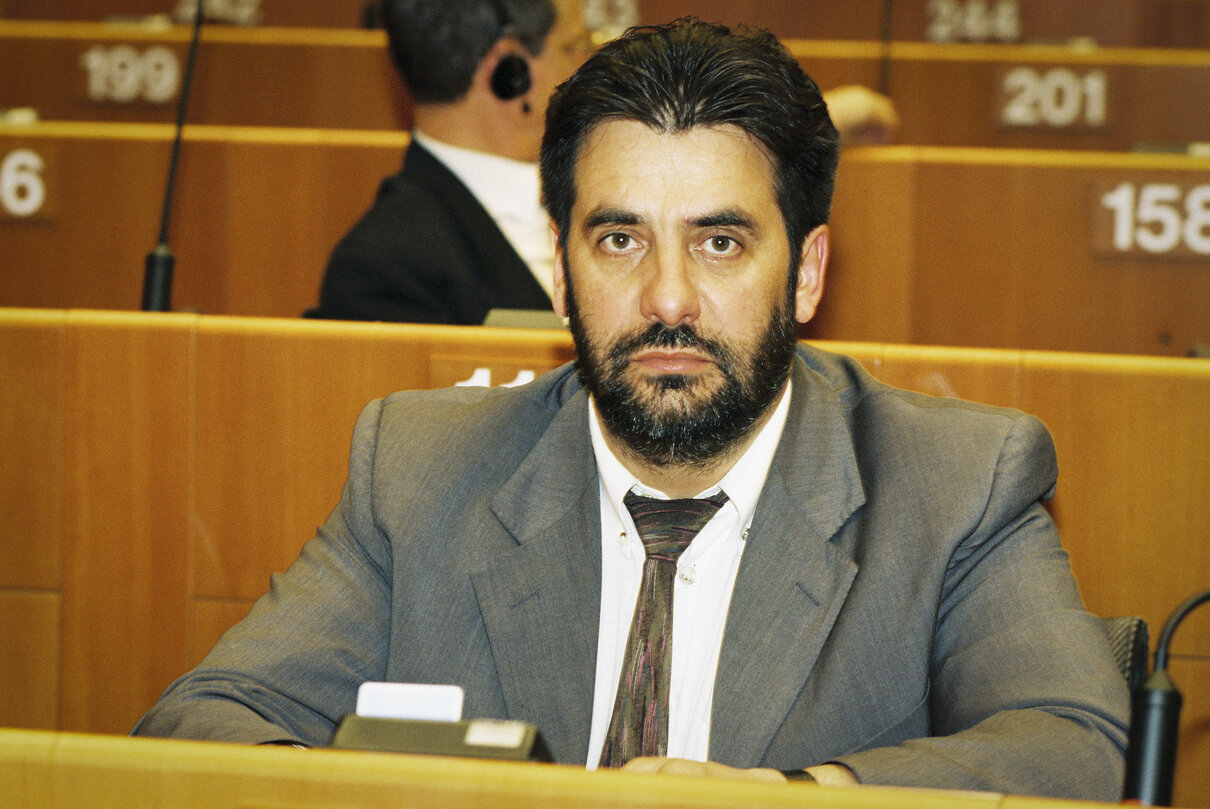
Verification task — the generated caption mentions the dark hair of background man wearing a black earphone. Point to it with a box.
[381,0,555,103]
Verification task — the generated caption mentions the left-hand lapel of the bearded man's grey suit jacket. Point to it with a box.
[472,391,600,762]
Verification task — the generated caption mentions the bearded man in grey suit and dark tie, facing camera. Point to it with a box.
[136,22,1129,801]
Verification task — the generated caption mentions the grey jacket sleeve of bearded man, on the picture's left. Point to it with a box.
[132,401,391,745]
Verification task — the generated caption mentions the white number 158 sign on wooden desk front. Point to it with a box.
[1093,181,1210,259]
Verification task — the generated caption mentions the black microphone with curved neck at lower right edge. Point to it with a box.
[1122,590,1210,807]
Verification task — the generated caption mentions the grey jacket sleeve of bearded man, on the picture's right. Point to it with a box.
[835,417,1129,801]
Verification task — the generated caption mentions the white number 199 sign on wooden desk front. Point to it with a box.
[80,45,180,104]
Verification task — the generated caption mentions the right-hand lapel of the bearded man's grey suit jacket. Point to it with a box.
[710,353,865,767]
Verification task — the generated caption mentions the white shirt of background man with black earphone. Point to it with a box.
[411,131,554,295]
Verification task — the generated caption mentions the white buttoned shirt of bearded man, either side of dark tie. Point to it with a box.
[588,385,791,769]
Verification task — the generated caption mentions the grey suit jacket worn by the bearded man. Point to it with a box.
[136,345,1129,801]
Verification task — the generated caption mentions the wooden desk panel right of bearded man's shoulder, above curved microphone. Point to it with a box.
[1020,354,1210,652]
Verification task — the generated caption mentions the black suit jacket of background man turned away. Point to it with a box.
[305,143,551,325]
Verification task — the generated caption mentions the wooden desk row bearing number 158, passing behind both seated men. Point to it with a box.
[0,123,1210,354]
